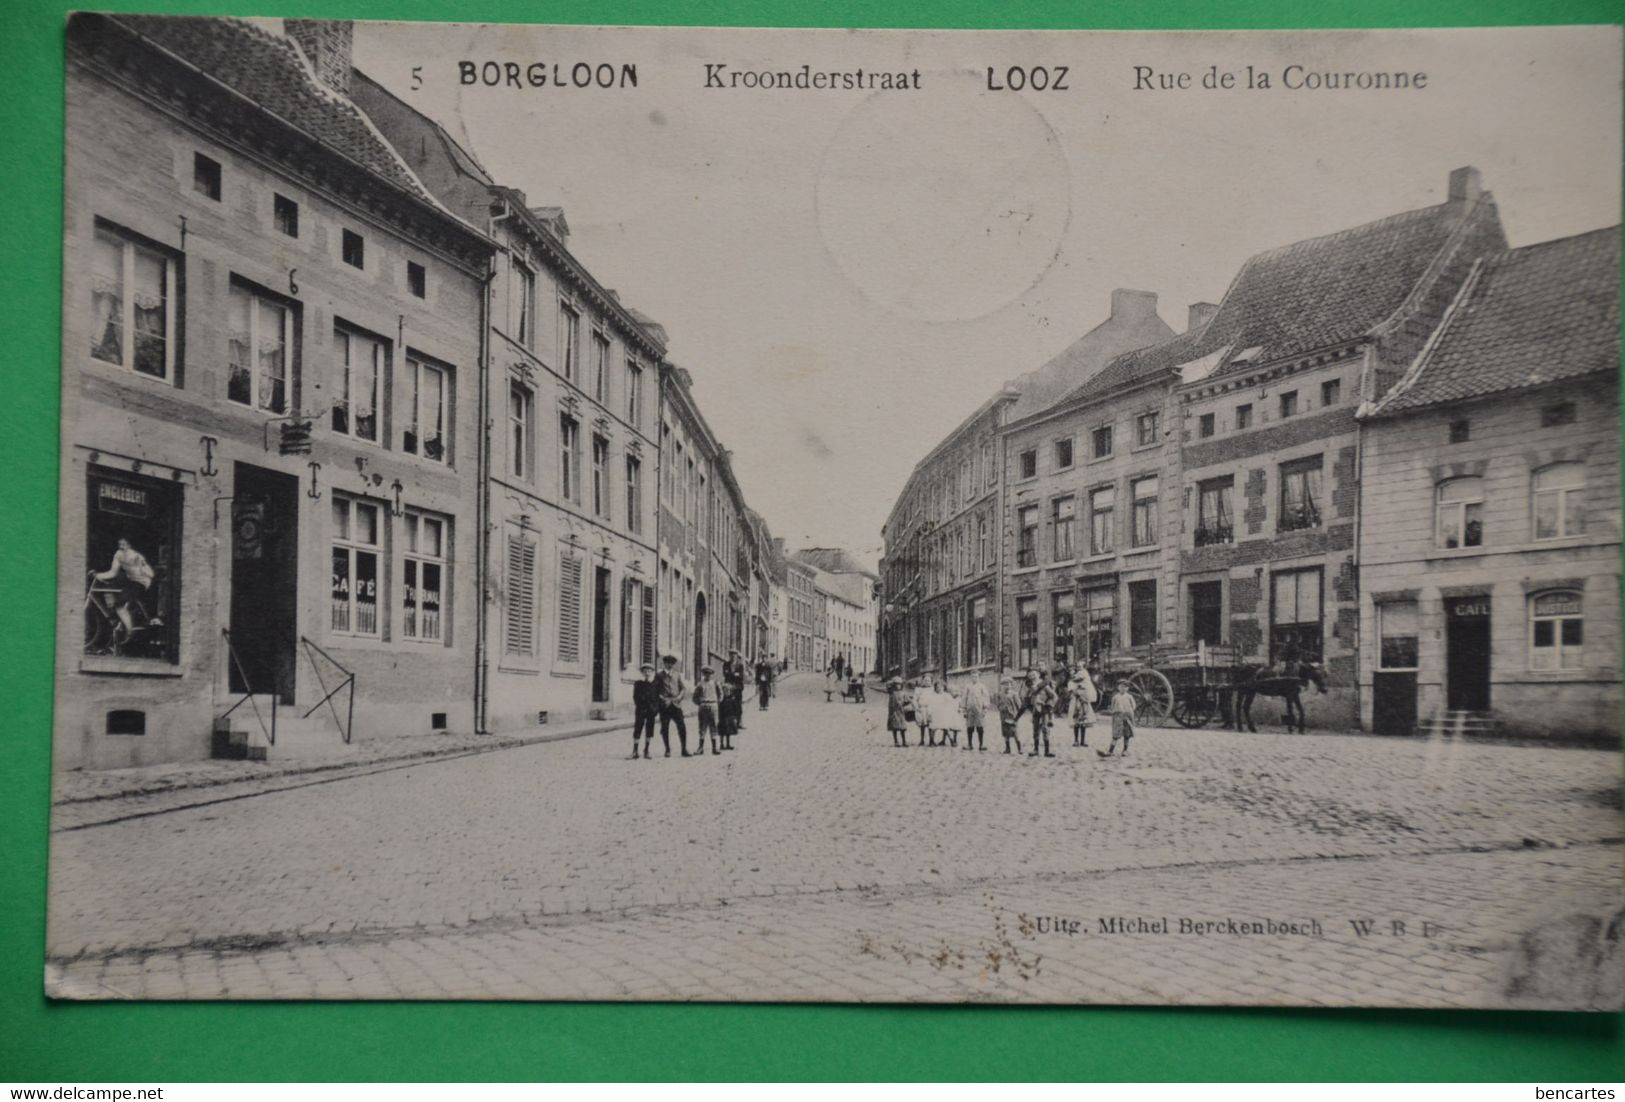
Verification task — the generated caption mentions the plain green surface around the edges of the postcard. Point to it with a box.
[0,0,1625,1084]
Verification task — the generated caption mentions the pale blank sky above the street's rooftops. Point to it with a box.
[356,23,1620,564]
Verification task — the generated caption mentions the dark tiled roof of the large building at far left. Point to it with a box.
[109,15,432,202]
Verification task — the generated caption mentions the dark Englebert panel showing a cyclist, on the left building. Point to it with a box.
[81,466,181,663]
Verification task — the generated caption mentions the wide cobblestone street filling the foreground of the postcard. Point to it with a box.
[47,678,1625,1006]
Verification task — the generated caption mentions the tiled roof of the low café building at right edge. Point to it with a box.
[1375,226,1620,416]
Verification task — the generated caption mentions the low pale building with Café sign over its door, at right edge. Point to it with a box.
[1360,226,1620,740]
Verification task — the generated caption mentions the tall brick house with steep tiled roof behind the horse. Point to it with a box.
[1172,167,1506,725]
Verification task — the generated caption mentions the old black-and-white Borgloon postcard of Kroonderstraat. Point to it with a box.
[44,13,1625,1009]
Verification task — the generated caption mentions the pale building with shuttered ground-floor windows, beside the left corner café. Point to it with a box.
[353,72,666,730]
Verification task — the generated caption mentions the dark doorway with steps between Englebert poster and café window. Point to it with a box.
[228,463,299,704]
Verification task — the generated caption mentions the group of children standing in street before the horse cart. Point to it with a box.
[886,668,1139,757]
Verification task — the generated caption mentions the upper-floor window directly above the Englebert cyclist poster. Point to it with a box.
[91,221,179,380]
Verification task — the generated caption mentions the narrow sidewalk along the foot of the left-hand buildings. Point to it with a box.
[50,717,632,812]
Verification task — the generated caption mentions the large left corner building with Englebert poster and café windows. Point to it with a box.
[55,15,492,769]
